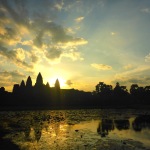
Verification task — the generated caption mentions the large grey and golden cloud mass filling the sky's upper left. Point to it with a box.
[0,0,88,70]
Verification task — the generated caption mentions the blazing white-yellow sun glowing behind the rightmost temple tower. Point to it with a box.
[49,77,66,88]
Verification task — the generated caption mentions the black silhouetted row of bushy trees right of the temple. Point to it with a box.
[94,82,150,106]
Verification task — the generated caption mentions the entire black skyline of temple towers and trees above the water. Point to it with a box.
[0,73,150,110]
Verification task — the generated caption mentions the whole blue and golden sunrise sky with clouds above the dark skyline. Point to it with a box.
[0,0,150,91]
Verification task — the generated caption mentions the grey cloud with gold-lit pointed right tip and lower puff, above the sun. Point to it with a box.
[31,22,88,60]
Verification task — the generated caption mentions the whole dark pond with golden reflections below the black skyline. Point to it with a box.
[0,109,150,150]
